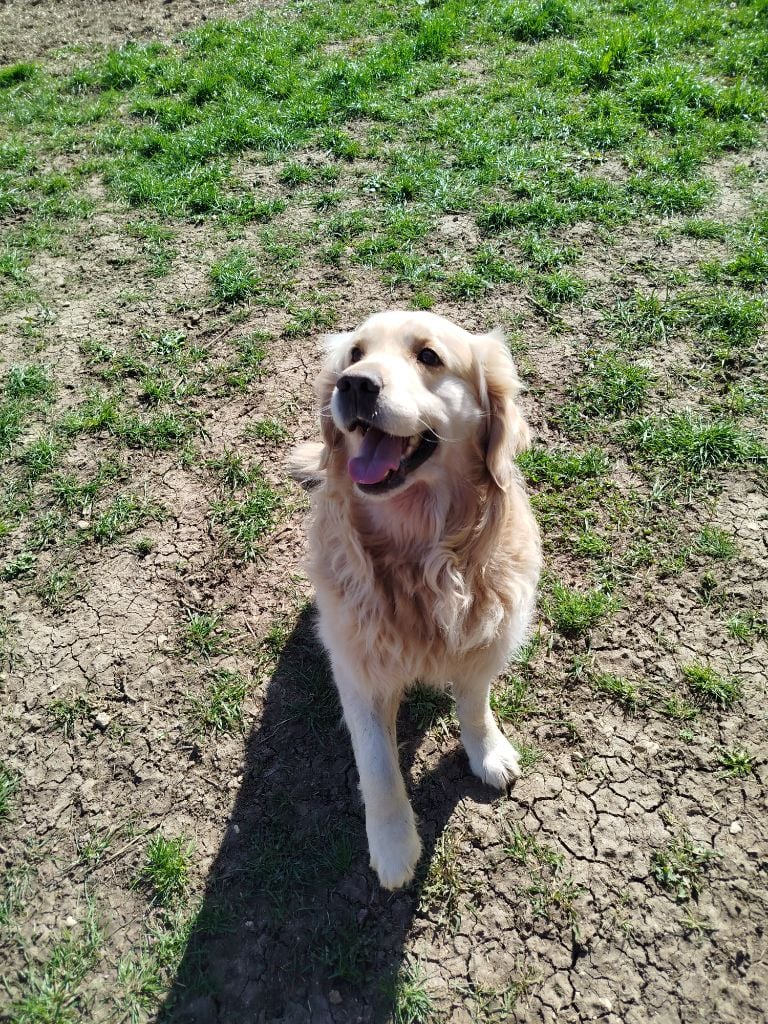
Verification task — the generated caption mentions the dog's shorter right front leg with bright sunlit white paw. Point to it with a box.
[454,677,520,790]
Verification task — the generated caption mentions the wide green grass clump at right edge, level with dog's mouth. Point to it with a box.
[625,411,768,477]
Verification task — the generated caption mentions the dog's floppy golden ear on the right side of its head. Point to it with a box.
[475,331,530,490]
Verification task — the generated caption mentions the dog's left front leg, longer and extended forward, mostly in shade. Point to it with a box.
[334,663,421,889]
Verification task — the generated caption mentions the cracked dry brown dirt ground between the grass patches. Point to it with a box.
[0,2,768,1024]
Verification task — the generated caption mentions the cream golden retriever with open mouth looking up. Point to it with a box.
[290,310,541,889]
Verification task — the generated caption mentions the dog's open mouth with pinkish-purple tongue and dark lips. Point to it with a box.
[347,420,437,495]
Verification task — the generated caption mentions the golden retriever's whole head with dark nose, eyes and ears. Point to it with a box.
[318,310,527,498]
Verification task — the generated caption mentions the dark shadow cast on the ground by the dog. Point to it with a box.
[160,609,493,1024]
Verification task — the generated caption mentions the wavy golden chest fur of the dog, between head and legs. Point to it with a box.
[309,475,538,689]
